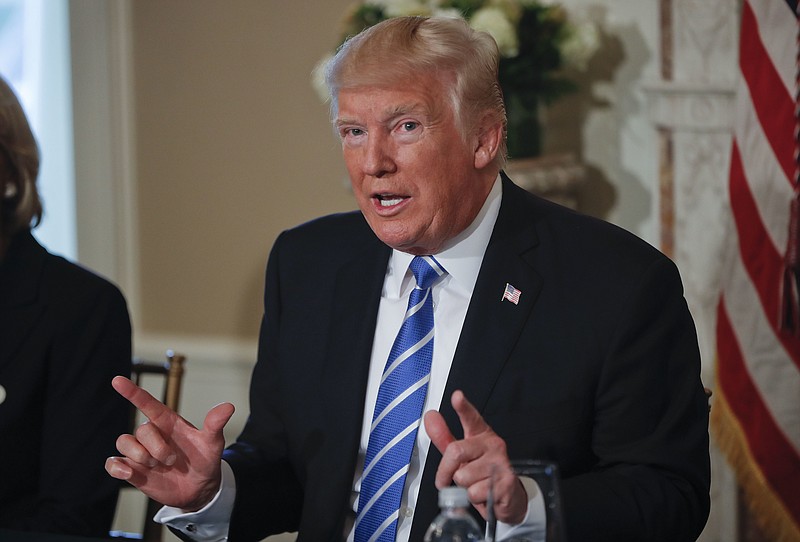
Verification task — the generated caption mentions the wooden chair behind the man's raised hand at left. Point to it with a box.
[110,350,186,542]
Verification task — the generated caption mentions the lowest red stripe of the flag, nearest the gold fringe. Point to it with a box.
[717,300,800,510]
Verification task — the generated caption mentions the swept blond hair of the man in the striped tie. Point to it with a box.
[325,17,507,167]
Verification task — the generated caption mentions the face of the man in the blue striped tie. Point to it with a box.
[336,77,495,254]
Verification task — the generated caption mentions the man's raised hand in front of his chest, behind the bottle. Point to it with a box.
[424,391,528,524]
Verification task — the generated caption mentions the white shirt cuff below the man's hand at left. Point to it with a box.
[153,461,236,542]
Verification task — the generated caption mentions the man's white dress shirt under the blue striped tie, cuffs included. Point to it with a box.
[155,177,544,542]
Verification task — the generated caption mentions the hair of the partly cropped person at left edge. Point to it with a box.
[0,77,42,248]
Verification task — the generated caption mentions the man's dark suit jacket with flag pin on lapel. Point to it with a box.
[225,178,710,542]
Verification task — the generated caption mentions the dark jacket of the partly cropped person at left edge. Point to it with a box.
[0,231,131,536]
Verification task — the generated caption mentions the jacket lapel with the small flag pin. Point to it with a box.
[411,176,541,539]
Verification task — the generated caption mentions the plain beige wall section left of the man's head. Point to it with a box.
[131,0,354,339]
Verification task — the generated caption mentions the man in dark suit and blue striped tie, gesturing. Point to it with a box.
[106,14,709,541]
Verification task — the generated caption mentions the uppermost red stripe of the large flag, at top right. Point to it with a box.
[739,2,797,184]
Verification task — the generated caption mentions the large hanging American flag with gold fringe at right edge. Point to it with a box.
[711,0,800,541]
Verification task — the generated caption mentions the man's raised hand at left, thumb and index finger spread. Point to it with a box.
[105,376,234,511]
